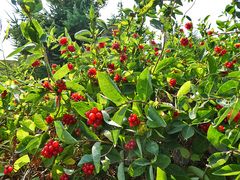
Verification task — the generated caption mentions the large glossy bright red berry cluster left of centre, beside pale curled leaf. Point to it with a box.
[85,107,103,128]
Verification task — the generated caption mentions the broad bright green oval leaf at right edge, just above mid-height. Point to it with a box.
[217,80,239,96]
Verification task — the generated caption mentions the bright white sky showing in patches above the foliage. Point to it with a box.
[0,0,231,59]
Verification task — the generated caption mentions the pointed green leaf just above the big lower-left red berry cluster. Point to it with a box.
[54,121,77,144]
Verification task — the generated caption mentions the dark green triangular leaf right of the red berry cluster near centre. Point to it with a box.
[147,106,167,128]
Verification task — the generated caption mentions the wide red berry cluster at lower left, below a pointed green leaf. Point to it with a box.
[41,139,63,158]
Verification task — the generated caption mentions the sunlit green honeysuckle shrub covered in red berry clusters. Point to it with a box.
[0,0,240,180]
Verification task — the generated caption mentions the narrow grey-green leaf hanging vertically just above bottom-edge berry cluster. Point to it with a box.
[92,142,101,174]
